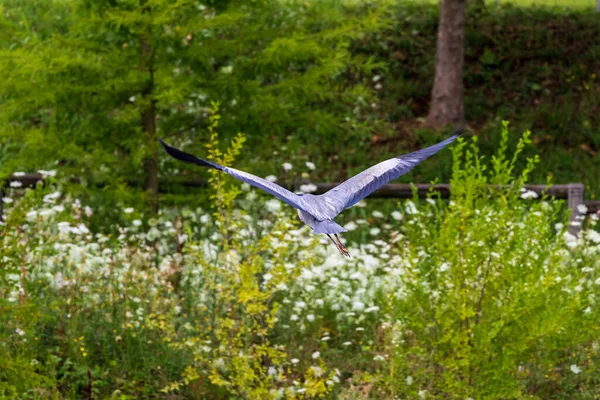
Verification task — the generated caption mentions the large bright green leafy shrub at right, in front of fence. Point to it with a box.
[391,123,598,399]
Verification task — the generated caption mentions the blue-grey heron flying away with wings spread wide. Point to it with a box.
[159,129,464,257]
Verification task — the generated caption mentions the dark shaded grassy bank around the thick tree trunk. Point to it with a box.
[358,2,600,196]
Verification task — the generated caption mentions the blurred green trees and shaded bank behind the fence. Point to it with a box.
[0,0,600,222]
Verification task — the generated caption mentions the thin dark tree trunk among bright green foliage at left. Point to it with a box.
[140,0,158,214]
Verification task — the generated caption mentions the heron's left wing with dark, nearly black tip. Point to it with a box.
[159,139,310,213]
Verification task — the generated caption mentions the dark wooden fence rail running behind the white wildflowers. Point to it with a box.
[0,174,600,233]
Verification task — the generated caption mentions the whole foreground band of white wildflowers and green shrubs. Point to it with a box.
[0,120,600,399]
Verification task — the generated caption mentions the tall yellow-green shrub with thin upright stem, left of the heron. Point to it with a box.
[159,105,335,399]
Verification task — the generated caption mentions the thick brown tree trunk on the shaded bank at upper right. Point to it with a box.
[427,0,465,128]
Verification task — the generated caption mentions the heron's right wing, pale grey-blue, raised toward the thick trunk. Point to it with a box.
[318,129,464,219]
